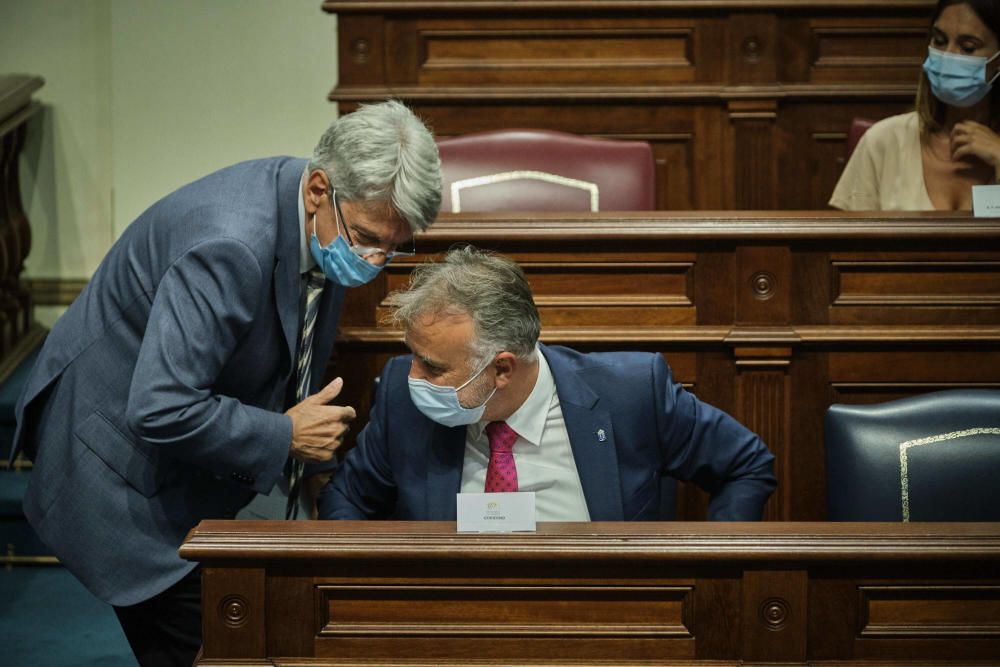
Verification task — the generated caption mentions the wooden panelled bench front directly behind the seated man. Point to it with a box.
[329,212,1000,521]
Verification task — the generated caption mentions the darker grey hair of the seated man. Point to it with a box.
[392,246,542,367]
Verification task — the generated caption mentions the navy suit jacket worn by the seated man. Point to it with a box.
[320,345,776,521]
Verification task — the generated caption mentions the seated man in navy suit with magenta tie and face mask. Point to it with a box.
[319,247,776,521]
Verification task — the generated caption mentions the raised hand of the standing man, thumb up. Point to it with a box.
[285,378,357,463]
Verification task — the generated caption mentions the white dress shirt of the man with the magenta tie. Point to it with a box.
[461,348,590,521]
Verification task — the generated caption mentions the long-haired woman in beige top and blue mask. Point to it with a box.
[830,0,1000,211]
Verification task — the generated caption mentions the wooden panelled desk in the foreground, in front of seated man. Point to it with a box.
[181,521,1000,667]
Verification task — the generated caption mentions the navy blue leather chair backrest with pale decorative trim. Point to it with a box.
[824,389,1000,521]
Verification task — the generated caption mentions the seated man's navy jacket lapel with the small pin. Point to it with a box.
[540,346,625,521]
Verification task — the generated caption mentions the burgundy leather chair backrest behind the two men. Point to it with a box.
[437,129,656,213]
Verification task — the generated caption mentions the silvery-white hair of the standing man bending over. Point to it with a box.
[309,100,441,232]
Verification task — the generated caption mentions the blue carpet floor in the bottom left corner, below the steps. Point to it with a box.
[0,565,136,667]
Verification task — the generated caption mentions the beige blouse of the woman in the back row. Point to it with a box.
[830,111,934,211]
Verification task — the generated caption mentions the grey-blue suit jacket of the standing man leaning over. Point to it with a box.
[14,158,343,605]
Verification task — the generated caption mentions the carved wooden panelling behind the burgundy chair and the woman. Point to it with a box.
[323,0,934,210]
